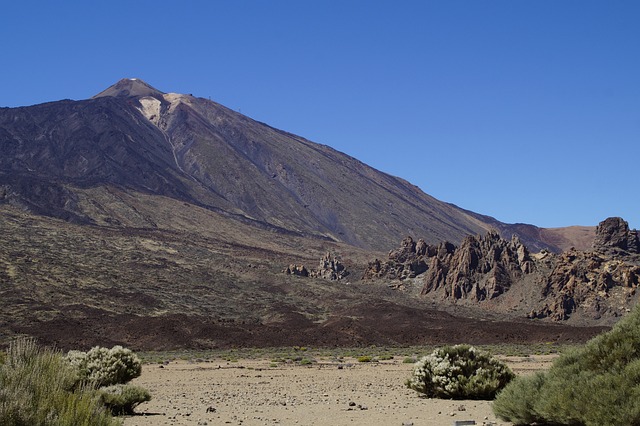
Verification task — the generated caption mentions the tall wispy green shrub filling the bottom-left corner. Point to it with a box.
[0,339,120,426]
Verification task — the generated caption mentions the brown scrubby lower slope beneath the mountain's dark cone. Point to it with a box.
[0,203,602,350]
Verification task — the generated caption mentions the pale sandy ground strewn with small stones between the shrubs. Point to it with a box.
[124,356,551,426]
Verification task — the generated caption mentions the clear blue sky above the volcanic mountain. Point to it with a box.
[0,0,640,228]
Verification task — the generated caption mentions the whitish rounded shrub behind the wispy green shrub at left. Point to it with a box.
[66,346,142,387]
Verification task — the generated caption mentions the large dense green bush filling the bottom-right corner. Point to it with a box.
[493,307,640,426]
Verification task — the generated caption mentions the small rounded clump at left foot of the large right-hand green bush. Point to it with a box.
[493,372,545,425]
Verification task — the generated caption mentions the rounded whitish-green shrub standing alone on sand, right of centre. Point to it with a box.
[406,345,514,399]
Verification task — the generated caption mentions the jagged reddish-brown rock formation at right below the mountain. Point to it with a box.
[363,218,640,321]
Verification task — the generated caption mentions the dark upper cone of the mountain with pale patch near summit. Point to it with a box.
[0,79,559,251]
